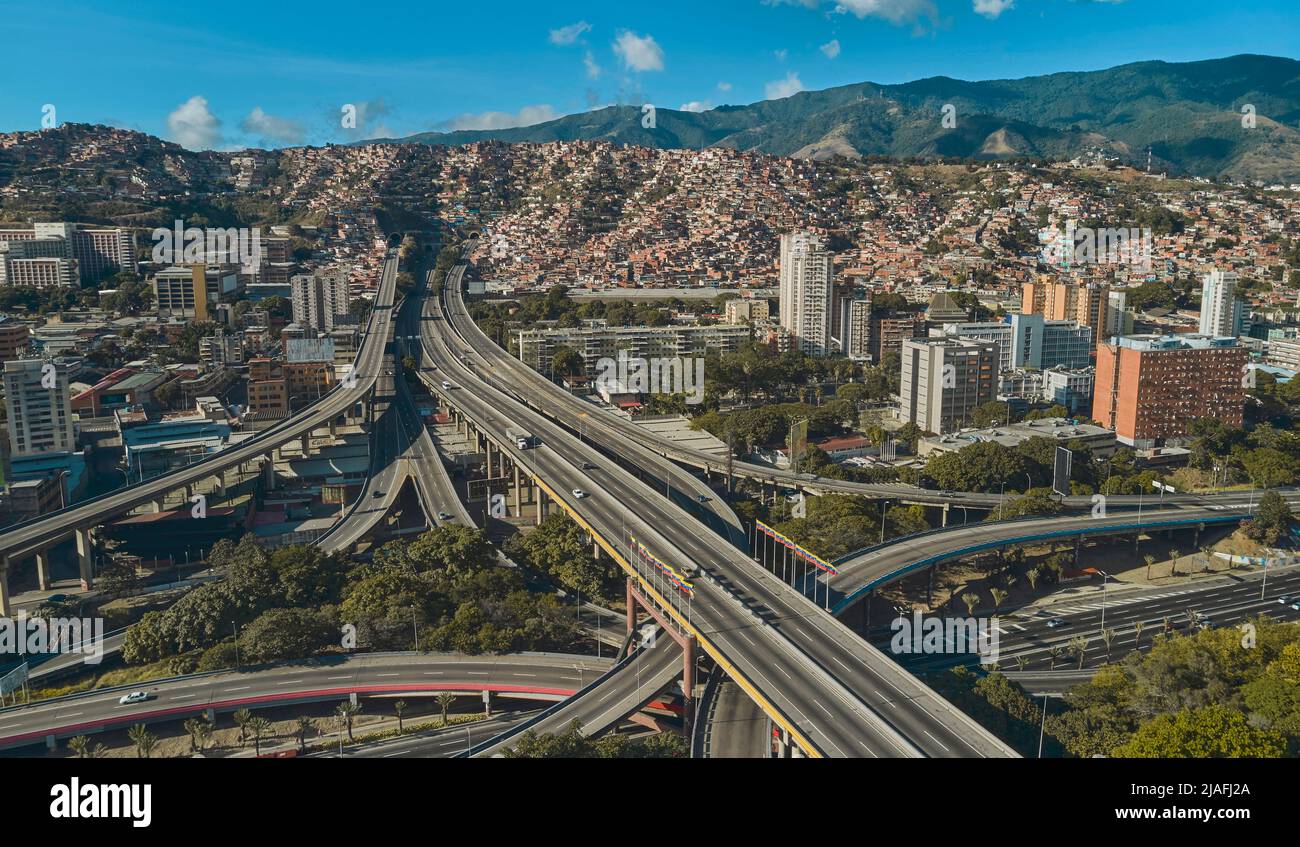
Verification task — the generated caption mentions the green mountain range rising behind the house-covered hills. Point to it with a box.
[367,55,1300,183]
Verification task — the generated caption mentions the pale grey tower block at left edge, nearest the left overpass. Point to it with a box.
[4,359,77,459]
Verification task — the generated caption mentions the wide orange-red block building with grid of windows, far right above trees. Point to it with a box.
[1092,335,1247,447]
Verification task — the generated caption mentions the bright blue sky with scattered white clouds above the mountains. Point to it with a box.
[0,0,1300,149]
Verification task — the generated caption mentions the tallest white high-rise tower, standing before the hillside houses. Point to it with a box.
[780,233,835,356]
